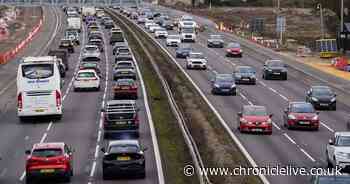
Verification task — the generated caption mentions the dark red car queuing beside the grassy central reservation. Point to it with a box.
[113,78,138,99]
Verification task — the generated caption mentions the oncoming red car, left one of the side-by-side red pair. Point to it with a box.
[237,105,272,135]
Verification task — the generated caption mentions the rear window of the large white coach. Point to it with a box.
[22,64,54,79]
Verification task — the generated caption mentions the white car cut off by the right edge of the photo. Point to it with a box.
[326,132,350,169]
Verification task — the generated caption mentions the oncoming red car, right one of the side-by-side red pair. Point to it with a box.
[283,102,320,130]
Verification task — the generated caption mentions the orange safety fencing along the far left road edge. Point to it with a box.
[0,9,44,64]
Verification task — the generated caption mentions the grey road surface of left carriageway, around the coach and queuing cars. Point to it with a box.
[0,7,161,184]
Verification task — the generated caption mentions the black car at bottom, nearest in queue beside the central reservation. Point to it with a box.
[101,139,147,180]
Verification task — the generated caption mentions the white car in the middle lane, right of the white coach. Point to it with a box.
[73,69,101,91]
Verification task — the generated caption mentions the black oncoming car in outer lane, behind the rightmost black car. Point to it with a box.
[262,60,288,80]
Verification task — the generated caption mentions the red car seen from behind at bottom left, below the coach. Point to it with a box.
[26,142,73,184]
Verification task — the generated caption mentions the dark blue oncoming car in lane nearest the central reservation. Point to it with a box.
[211,74,237,96]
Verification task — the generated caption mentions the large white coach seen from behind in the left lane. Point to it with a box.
[17,56,63,121]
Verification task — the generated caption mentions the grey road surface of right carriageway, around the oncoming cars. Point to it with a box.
[117,7,350,184]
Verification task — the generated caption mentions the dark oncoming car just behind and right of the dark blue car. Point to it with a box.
[233,66,256,85]
